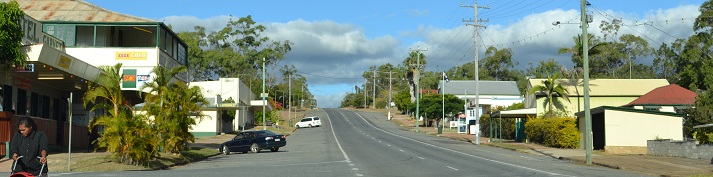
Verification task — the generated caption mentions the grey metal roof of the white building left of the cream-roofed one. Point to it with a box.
[438,80,521,96]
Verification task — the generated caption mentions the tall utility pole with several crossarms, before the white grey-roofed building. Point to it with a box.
[461,3,490,144]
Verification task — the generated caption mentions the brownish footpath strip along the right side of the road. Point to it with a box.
[384,115,713,176]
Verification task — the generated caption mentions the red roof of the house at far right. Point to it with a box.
[624,84,697,106]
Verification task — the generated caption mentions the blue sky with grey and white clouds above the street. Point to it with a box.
[87,0,704,107]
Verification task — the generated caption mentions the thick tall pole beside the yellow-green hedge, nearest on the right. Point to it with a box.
[580,0,592,165]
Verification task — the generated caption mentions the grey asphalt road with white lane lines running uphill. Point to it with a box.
[43,109,644,177]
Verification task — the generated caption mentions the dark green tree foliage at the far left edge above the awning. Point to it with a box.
[0,1,27,69]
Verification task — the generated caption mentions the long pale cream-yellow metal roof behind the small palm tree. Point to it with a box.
[528,79,669,96]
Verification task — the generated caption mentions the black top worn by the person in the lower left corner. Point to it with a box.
[10,131,48,176]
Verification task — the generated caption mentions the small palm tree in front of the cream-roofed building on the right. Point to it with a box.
[529,73,569,115]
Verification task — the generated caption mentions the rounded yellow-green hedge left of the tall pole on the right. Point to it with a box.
[525,117,580,149]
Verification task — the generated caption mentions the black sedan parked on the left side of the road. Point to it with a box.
[220,130,287,155]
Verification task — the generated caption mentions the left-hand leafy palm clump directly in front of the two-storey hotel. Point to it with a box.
[82,63,156,164]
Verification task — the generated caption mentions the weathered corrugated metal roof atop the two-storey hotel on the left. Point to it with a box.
[0,0,157,22]
